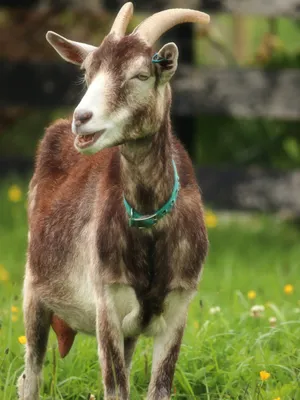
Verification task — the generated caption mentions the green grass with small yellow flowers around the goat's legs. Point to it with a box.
[0,179,300,400]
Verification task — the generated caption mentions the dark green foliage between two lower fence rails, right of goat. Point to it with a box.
[192,116,300,168]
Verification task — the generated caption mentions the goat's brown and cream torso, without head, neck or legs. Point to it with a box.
[27,121,206,336]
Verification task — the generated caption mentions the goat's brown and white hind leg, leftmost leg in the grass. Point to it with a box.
[18,278,51,400]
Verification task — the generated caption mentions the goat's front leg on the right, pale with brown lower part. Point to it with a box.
[147,290,193,400]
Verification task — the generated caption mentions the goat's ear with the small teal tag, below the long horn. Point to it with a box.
[157,43,179,83]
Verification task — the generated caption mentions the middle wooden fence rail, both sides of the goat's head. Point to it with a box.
[0,60,300,120]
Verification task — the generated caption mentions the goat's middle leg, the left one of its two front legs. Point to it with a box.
[97,291,130,400]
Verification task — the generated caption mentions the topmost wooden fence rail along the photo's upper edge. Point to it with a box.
[0,0,300,18]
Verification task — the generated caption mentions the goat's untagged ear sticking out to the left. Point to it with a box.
[46,31,97,65]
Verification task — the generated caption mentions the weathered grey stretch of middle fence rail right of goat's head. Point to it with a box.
[173,66,300,120]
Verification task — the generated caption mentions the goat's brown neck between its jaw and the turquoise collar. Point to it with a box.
[121,121,174,214]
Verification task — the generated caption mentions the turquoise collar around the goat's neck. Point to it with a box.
[123,160,180,228]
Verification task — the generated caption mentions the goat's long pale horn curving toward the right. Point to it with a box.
[133,8,210,46]
